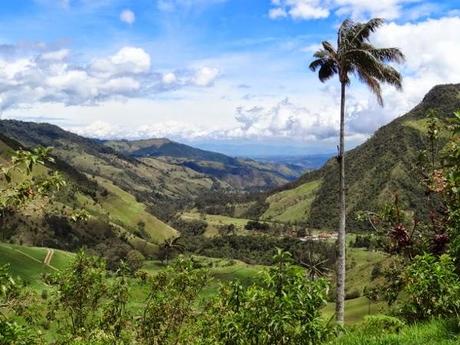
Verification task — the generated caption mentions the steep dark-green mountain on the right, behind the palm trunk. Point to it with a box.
[261,84,460,229]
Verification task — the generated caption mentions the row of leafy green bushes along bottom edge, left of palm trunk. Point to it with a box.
[0,251,329,345]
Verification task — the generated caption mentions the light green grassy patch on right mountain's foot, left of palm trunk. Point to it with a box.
[262,181,321,222]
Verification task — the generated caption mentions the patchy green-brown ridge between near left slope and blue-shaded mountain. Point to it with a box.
[0,120,226,219]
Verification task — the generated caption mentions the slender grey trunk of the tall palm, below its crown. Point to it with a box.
[335,82,346,325]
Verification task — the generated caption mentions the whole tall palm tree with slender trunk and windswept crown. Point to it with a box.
[310,18,404,324]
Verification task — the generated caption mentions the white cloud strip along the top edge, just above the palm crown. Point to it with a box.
[268,0,433,20]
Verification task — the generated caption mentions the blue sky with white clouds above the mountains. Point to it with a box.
[0,0,460,155]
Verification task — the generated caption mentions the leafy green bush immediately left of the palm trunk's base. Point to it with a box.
[200,251,329,345]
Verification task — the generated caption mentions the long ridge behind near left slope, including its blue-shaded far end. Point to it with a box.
[0,120,308,221]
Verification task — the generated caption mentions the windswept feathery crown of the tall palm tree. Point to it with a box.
[310,18,404,105]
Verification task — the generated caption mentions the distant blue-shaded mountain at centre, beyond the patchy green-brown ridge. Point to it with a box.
[105,139,305,190]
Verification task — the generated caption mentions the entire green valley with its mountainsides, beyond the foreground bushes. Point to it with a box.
[0,76,460,344]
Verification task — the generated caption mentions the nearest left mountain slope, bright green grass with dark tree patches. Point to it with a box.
[0,132,177,255]
